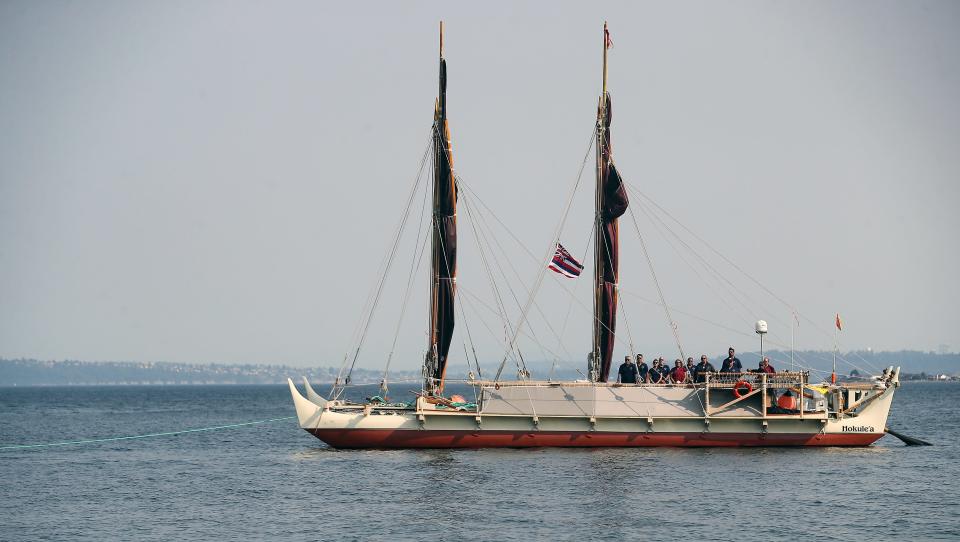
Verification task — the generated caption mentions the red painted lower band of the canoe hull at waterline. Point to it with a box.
[306,429,883,448]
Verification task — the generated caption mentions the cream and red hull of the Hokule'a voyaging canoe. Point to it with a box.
[289,381,896,449]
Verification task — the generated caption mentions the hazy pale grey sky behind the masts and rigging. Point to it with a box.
[0,1,960,370]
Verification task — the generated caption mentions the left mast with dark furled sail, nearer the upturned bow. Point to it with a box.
[424,23,457,392]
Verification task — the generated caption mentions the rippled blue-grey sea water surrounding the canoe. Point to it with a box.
[0,382,960,541]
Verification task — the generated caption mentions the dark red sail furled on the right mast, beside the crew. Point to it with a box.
[593,94,629,382]
